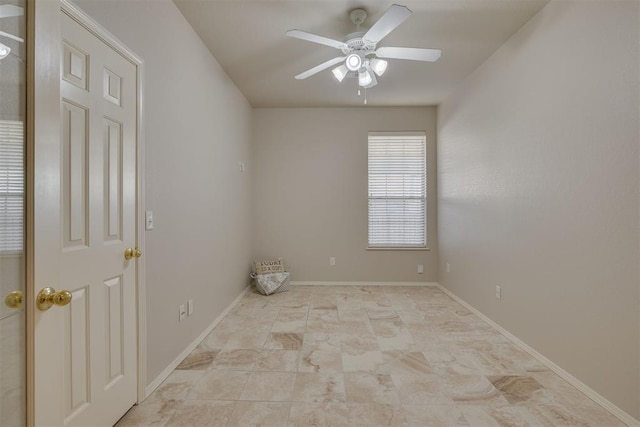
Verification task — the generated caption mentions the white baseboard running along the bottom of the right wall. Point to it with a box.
[436,283,640,427]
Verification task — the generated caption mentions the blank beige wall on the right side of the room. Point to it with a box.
[438,1,640,418]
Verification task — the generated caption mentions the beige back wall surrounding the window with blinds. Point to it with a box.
[252,107,437,282]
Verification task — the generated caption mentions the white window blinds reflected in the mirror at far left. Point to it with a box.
[0,120,24,253]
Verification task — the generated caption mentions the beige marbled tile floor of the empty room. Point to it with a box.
[117,286,624,427]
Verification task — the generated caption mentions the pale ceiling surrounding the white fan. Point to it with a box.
[174,0,549,107]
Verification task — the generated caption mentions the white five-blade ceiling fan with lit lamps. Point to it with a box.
[286,4,442,88]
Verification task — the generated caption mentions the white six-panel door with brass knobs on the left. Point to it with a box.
[34,4,138,426]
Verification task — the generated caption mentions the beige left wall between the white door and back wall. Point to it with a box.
[77,0,251,382]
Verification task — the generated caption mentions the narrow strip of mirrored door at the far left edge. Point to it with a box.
[0,0,27,427]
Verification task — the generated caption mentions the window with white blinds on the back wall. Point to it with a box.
[368,132,427,249]
